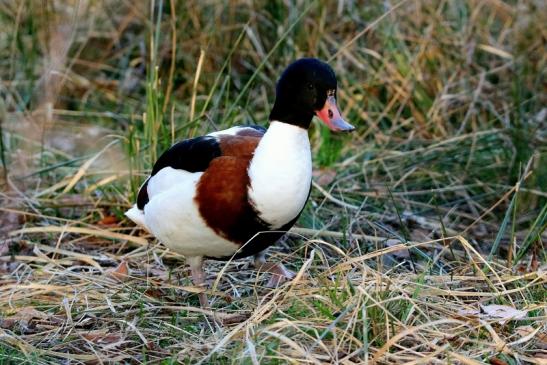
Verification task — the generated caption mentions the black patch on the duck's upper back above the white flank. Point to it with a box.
[150,136,222,176]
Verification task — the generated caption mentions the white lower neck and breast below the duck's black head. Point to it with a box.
[248,121,312,229]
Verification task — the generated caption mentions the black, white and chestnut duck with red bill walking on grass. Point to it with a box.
[125,58,355,307]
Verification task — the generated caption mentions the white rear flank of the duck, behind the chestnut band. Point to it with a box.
[140,167,239,257]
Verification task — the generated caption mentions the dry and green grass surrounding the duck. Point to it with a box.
[0,0,547,365]
